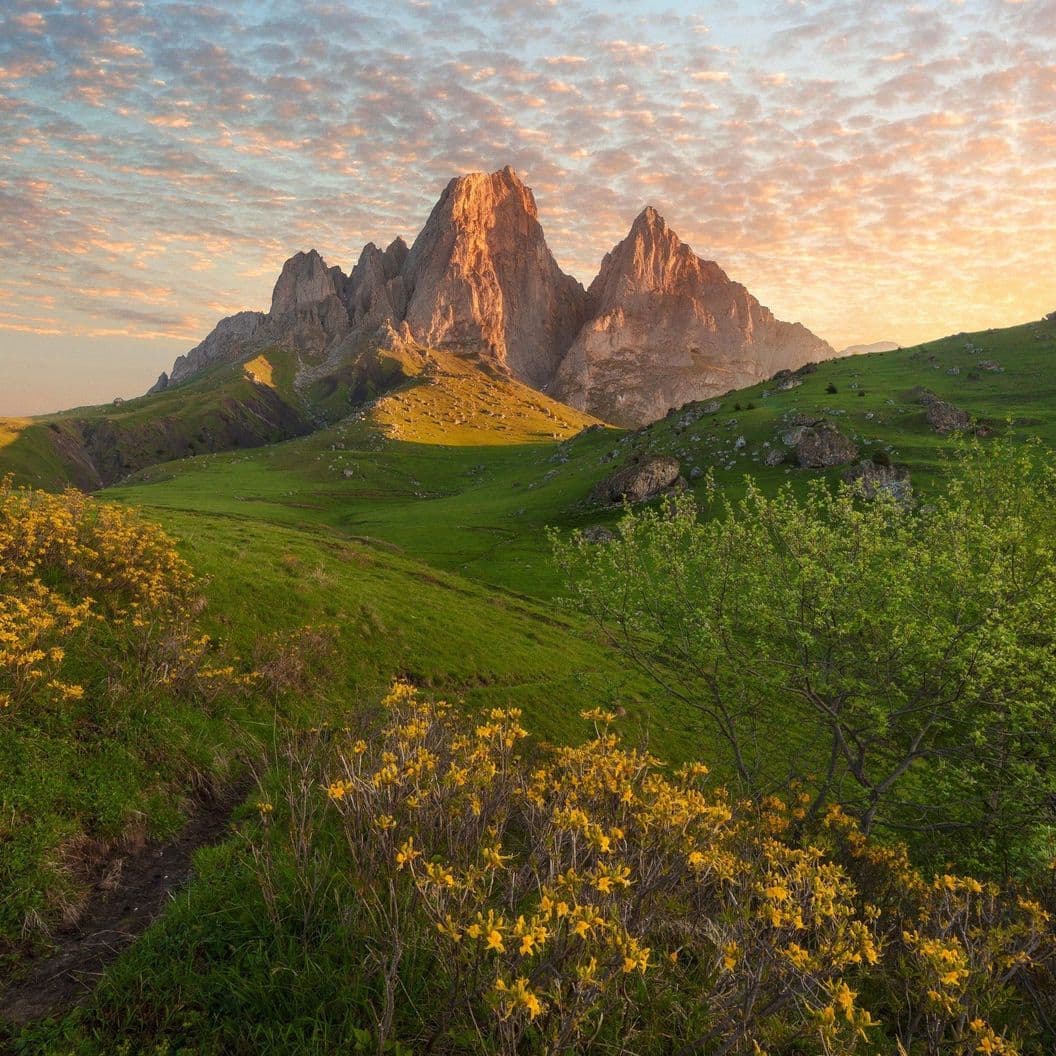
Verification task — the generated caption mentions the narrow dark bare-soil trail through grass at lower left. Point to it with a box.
[0,788,245,1026]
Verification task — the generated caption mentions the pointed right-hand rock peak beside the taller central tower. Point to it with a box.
[549,208,835,427]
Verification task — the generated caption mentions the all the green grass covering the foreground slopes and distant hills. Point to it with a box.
[0,323,1056,1056]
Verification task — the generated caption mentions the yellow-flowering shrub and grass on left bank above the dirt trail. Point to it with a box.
[0,479,246,949]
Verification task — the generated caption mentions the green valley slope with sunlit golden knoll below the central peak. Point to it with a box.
[100,351,619,593]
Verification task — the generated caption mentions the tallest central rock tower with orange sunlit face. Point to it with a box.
[401,167,586,388]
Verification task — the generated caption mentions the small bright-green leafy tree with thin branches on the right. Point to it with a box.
[557,442,1056,872]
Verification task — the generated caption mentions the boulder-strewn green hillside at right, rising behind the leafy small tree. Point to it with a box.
[623,314,1056,489]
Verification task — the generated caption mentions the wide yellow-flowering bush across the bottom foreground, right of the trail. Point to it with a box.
[261,682,1053,1054]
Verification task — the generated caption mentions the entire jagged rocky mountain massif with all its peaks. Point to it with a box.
[152,167,833,426]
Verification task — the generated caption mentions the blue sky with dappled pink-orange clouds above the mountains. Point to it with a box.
[0,0,1056,415]
